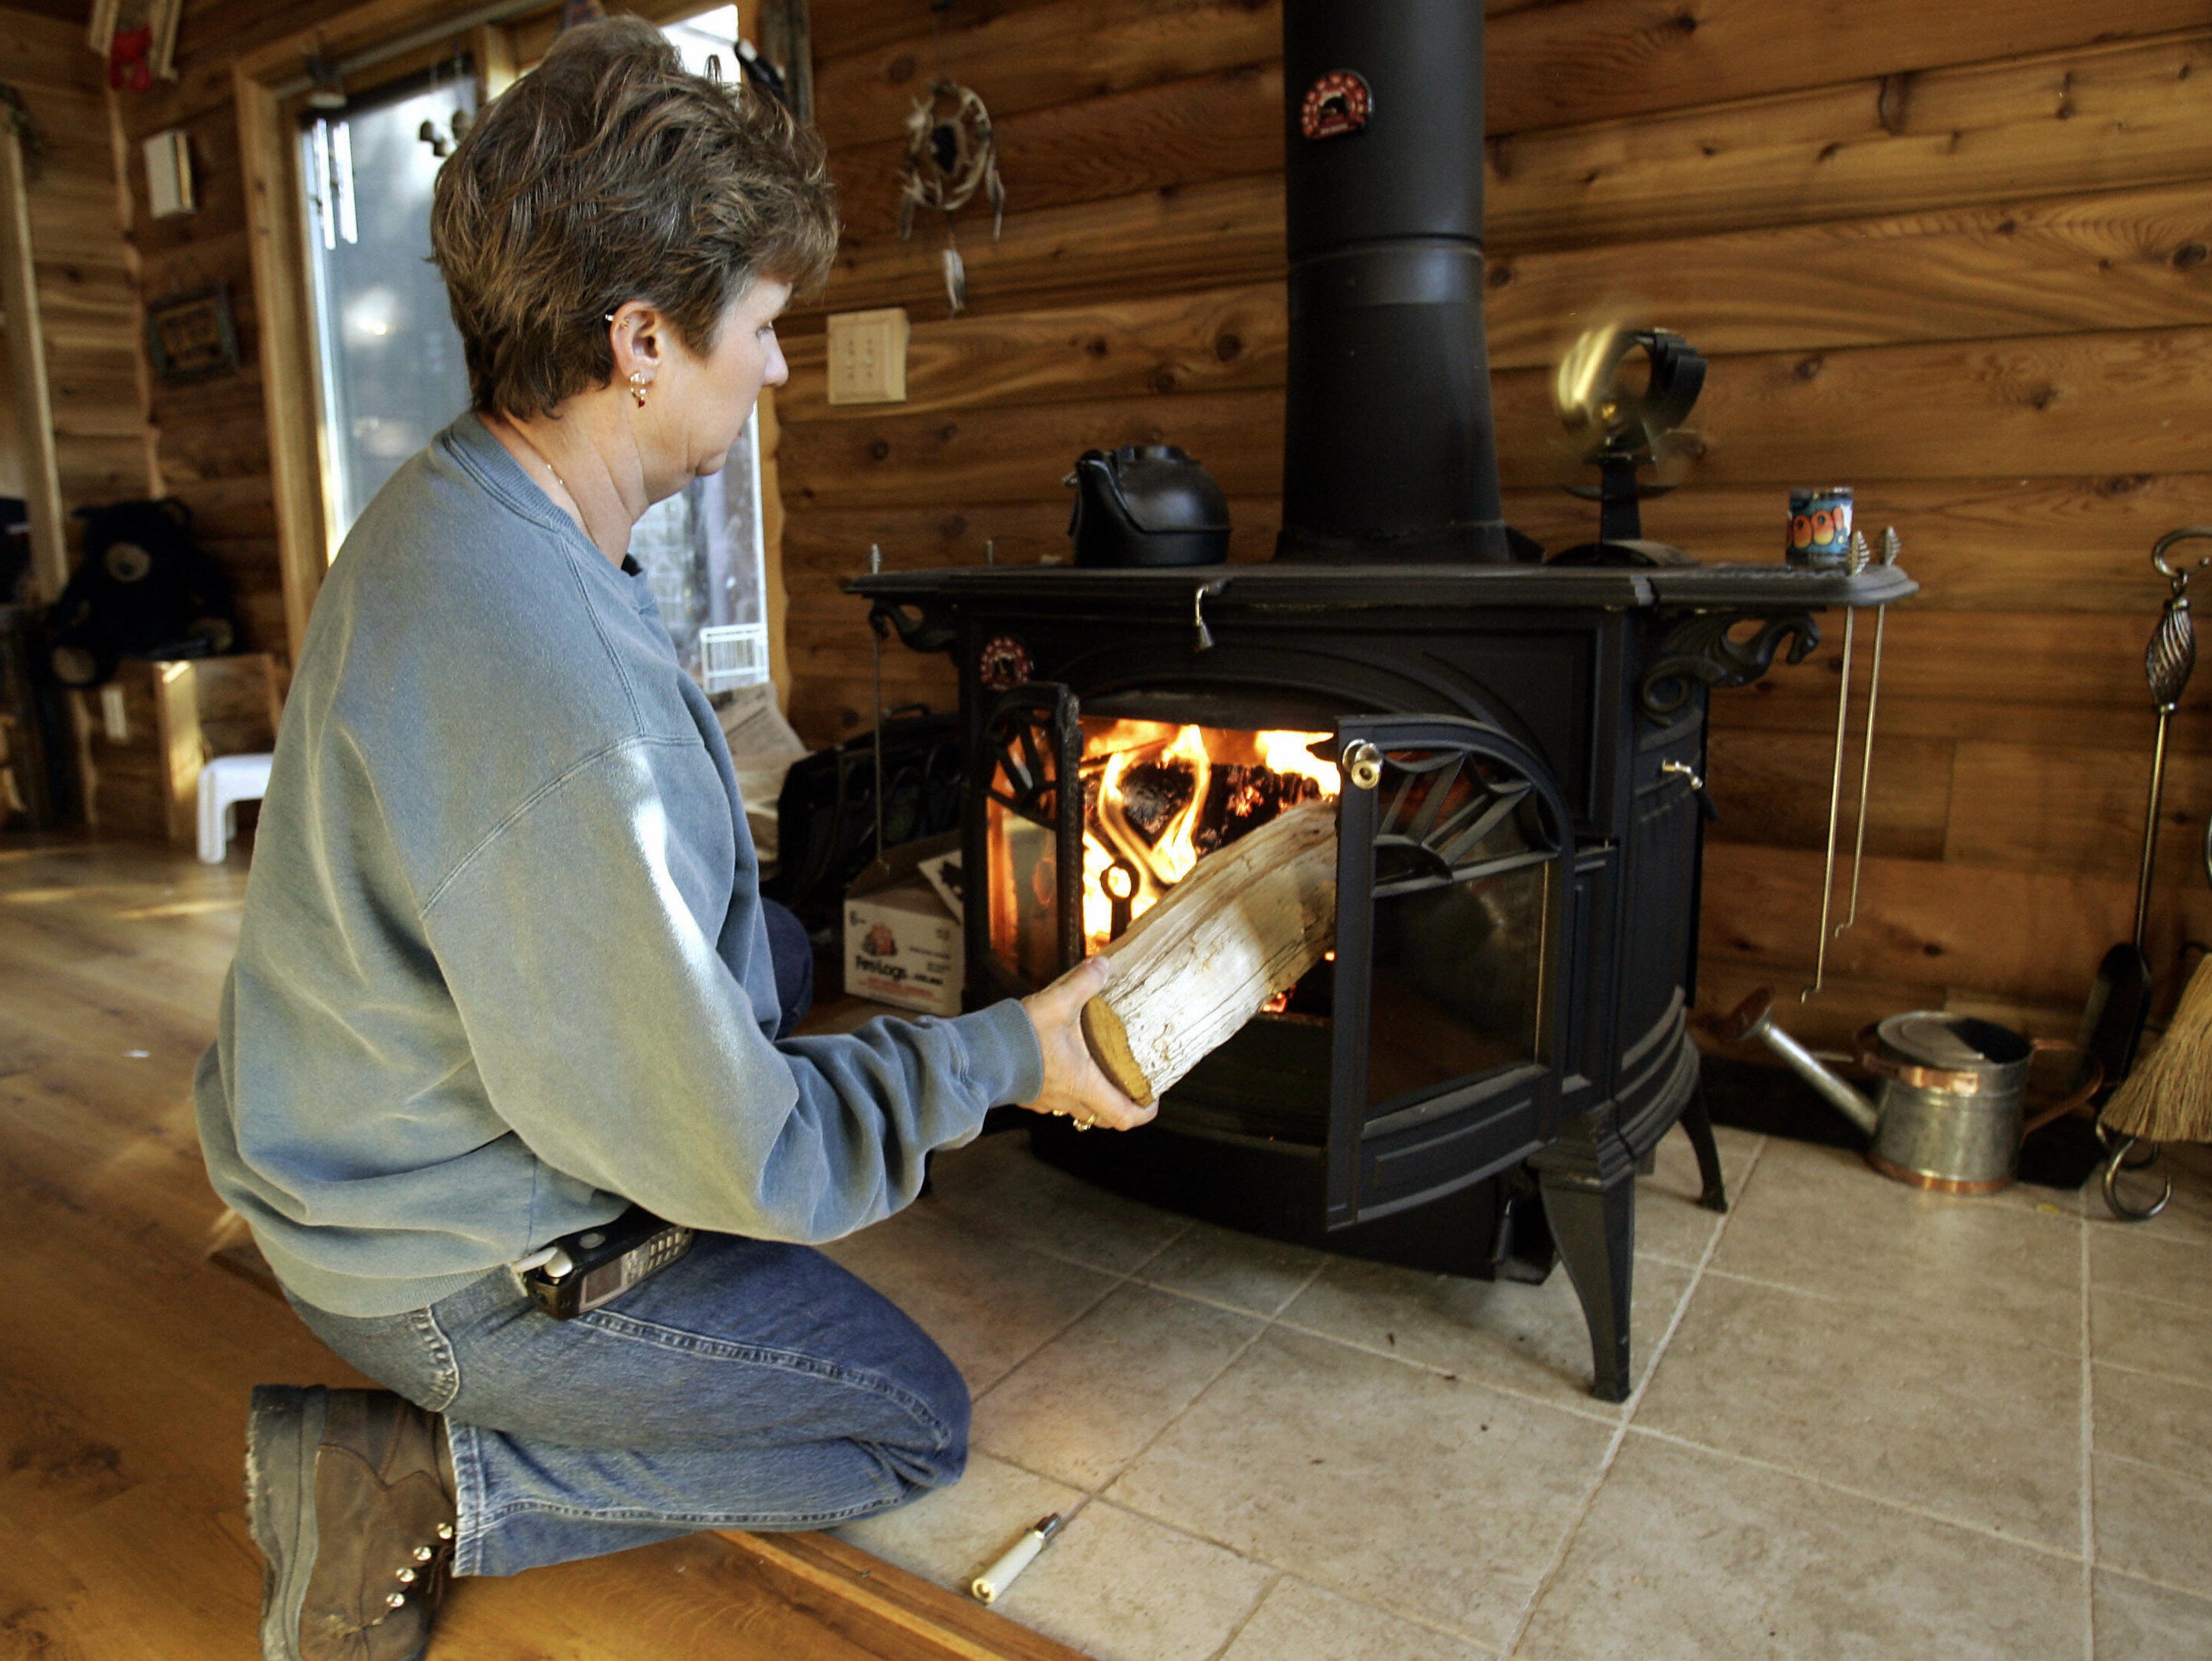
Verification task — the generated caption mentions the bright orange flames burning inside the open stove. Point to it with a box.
[1066,719,1340,951]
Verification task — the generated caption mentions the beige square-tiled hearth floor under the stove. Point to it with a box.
[831,1130,2212,1661]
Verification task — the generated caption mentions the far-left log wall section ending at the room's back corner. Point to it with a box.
[0,7,151,570]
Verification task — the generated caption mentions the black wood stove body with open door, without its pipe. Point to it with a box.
[854,564,1914,1400]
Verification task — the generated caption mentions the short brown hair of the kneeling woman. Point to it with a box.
[429,18,838,416]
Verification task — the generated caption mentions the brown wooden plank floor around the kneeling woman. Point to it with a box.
[0,838,1075,1661]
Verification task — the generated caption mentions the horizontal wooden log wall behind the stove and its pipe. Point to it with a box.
[779,0,2212,1042]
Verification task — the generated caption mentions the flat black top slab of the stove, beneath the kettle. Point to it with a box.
[845,564,1920,617]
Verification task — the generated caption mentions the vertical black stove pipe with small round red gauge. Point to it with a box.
[1276,0,1511,562]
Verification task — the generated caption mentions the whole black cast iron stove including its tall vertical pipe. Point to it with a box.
[851,0,1914,1400]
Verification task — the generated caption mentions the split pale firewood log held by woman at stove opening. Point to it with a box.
[1084,800,1336,1101]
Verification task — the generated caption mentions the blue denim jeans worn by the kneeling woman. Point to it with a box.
[292,1235,969,1575]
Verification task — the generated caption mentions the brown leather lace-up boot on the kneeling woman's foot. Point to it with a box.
[245,1385,454,1661]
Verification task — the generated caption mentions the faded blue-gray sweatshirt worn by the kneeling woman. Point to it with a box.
[195,416,1042,1316]
